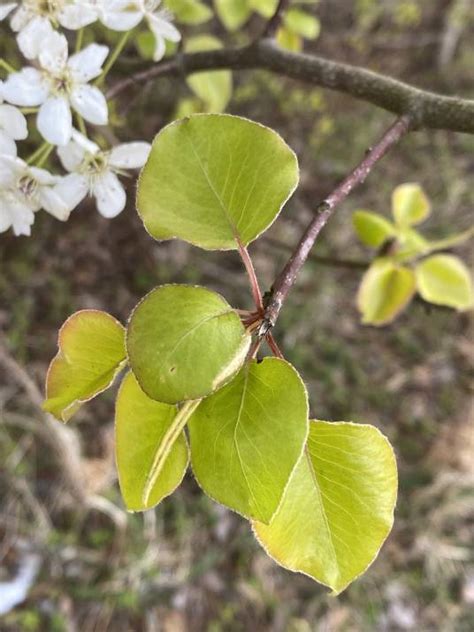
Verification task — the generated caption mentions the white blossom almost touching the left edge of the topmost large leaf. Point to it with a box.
[55,132,151,218]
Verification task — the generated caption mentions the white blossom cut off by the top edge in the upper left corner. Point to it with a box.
[0,0,97,59]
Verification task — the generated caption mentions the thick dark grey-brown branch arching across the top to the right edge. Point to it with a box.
[107,39,474,134]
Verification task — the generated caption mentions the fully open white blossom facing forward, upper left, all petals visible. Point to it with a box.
[3,32,109,145]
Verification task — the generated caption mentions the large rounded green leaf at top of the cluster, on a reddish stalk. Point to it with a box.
[137,114,298,250]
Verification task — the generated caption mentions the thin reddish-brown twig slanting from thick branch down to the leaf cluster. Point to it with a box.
[260,116,412,333]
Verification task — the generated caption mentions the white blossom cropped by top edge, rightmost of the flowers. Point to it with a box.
[99,0,181,61]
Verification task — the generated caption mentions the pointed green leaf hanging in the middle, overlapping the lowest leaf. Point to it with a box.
[189,358,308,522]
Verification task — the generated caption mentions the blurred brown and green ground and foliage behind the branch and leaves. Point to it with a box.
[0,0,474,632]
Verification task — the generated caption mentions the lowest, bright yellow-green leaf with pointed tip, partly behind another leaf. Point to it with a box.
[254,421,397,593]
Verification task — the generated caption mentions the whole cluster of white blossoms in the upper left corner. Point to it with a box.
[0,0,180,235]
